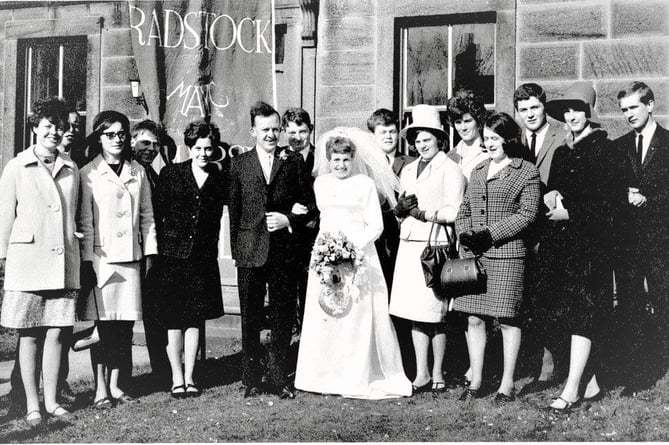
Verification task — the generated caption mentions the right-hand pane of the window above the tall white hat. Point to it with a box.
[453,23,495,104]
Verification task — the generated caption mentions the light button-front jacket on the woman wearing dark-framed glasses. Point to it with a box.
[79,155,158,286]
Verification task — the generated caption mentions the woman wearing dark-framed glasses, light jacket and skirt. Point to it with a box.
[80,111,157,409]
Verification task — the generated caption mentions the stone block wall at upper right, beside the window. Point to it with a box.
[516,0,669,138]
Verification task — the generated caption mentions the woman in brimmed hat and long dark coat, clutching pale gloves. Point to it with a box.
[538,82,627,411]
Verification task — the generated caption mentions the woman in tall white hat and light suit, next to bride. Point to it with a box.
[390,105,465,392]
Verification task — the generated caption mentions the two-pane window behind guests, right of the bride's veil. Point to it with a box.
[394,12,496,151]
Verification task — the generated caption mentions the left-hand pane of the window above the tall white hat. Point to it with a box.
[405,26,448,106]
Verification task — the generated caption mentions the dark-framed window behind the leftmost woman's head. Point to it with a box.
[14,36,88,154]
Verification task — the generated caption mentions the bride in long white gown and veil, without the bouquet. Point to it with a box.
[295,128,411,399]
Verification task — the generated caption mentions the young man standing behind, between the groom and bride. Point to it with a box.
[281,107,318,325]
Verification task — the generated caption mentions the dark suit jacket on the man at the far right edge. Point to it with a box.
[614,125,669,258]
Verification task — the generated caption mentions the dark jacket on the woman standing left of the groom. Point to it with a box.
[153,159,226,258]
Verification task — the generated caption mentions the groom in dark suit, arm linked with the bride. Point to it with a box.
[228,102,314,399]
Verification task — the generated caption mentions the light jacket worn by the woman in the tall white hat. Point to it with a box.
[400,152,465,242]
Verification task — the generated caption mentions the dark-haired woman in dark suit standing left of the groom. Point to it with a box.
[154,121,225,398]
